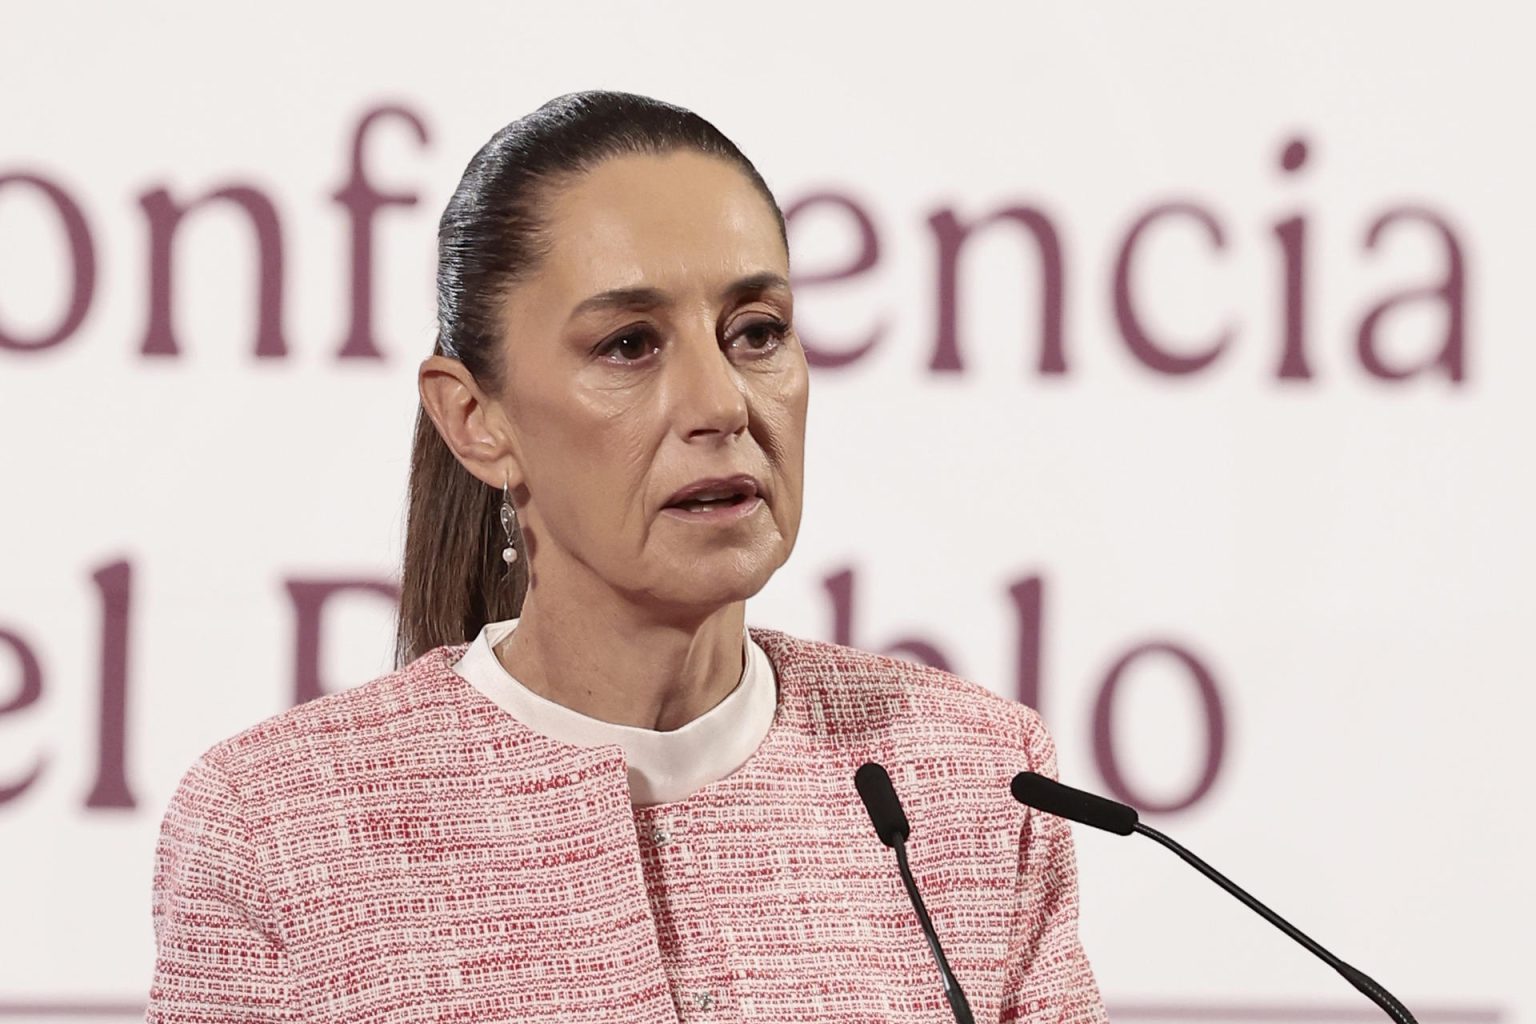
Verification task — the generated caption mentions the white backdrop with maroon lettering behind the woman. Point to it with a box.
[0,2,1536,1024]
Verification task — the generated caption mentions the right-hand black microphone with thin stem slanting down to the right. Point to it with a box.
[1011,772,1418,1024]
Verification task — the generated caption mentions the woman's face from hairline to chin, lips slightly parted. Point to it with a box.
[498,152,806,614]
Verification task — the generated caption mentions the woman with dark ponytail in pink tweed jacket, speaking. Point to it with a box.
[149,94,1104,1022]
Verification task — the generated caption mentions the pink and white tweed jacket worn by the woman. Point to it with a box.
[147,629,1106,1024]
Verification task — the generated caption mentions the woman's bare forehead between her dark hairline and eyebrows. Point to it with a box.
[538,150,788,302]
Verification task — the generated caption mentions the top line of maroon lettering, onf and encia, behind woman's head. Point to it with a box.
[0,106,1467,382]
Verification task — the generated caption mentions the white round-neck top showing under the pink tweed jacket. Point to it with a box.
[453,619,779,806]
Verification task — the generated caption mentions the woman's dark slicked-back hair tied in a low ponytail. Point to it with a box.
[395,92,785,665]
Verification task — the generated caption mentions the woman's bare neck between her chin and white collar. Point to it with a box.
[496,588,746,731]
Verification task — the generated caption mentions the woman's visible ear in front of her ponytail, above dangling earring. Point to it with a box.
[416,356,522,490]
